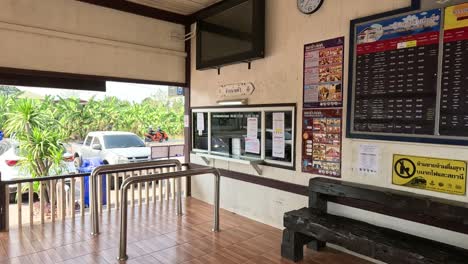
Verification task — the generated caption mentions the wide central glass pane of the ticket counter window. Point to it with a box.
[211,112,262,158]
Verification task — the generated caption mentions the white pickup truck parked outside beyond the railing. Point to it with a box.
[73,131,151,168]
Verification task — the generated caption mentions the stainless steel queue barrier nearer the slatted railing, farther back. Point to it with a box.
[90,159,182,235]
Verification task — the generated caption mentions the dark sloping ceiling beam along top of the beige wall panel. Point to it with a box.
[76,0,190,25]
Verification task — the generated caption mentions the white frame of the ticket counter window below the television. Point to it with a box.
[190,104,297,170]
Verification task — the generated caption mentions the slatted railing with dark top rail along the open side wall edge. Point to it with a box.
[0,160,186,233]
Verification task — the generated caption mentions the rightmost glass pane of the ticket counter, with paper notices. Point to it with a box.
[265,111,294,163]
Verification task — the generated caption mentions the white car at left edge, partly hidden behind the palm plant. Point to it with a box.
[0,139,76,201]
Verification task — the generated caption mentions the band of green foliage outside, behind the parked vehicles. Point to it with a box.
[0,94,184,140]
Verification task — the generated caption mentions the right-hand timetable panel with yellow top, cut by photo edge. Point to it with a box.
[439,3,468,137]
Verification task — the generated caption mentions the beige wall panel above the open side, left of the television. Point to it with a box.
[0,0,186,83]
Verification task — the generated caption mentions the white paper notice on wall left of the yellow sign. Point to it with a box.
[357,144,380,175]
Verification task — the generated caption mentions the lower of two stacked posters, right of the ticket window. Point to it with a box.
[302,108,342,177]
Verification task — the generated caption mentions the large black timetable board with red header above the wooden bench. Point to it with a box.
[347,3,468,144]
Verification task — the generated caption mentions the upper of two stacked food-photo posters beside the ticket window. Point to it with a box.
[303,37,344,108]
